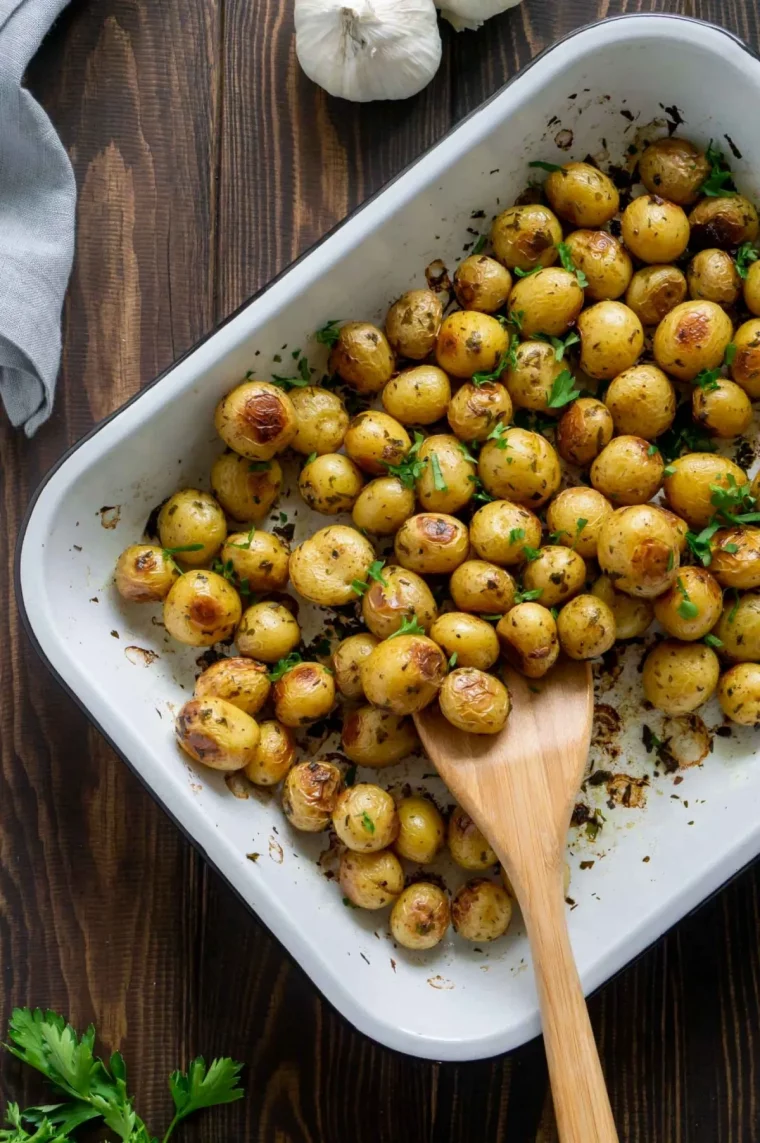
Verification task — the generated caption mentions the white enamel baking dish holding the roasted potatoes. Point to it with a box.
[17,16,760,1060]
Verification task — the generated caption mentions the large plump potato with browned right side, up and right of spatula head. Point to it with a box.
[597,504,681,599]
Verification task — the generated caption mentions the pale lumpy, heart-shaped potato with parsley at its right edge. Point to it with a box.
[290,523,375,607]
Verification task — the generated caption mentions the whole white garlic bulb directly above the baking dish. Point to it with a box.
[295,0,441,103]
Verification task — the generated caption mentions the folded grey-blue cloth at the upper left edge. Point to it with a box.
[0,0,77,437]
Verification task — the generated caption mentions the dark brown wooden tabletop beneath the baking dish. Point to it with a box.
[0,0,760,1143]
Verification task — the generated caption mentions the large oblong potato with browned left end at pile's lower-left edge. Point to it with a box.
[176,696,259,770]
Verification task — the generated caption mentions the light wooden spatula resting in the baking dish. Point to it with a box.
[415,662,617,1143]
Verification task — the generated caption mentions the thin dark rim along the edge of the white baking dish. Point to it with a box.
[14,13,760,1062]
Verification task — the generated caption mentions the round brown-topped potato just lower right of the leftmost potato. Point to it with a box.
[163,569,242,647]
